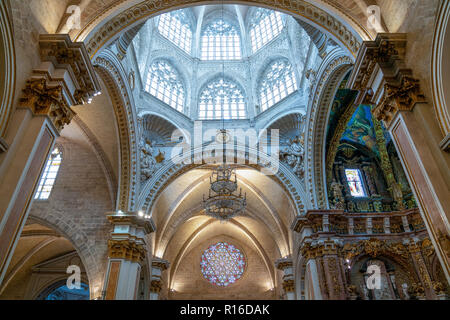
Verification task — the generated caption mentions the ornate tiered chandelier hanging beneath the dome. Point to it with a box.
[203,129,247,221]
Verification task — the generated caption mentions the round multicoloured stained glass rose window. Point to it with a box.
[200,242,245,287]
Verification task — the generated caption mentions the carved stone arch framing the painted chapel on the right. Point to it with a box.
[305,50,353,209]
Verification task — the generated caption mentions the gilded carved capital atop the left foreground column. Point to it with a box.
[20,34,101,132]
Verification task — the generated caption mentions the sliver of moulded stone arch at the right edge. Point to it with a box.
[431,1,450,139]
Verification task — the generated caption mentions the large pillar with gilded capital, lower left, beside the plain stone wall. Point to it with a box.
[104,212,155,300]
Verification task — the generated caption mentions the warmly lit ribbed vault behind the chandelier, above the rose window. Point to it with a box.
[149,169,294,258]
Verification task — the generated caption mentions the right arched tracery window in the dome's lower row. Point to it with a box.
[259,59,298,111]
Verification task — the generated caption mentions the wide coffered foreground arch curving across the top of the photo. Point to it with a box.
[75,0,366,58]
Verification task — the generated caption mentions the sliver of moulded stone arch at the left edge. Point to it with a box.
[0,1,16,140]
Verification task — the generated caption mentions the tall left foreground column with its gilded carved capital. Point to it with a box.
[0,35,100,283]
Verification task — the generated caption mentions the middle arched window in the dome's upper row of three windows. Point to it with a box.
[201,19,242,60]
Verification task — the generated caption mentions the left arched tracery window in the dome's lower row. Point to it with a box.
[145,60,185,112]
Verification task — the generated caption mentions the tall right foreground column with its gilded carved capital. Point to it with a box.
[349,34,450,282]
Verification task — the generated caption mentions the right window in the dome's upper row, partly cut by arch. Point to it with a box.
[250,8,283,52]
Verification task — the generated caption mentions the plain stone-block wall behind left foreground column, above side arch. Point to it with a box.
[30,124,113,292]
